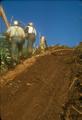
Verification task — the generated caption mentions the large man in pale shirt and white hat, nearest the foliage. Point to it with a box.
[6,21,25,61]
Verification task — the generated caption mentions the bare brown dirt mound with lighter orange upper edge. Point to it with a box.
[0,49,79,120]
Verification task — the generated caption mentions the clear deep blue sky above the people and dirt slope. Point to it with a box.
[0,0,82,47]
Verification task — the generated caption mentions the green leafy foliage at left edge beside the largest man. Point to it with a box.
[0,39,12,73]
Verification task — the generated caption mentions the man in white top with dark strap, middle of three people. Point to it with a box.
[25,22,37,54]
